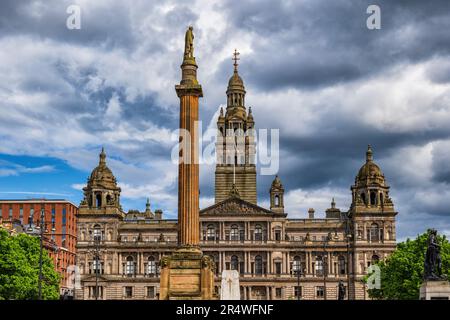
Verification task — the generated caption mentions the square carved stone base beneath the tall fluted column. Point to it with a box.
[159,247,216,300]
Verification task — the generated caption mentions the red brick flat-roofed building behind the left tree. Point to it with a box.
[0,199,78,293]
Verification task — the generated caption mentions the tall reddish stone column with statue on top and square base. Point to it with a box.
[160,27,215,300]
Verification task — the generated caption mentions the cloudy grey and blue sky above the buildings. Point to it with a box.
[0,0,450,240]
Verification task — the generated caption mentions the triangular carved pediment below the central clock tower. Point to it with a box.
[200,197,273,215]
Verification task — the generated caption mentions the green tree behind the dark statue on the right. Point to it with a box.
[365,232,450,300]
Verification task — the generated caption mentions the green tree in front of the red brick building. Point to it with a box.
[0,229,60,300]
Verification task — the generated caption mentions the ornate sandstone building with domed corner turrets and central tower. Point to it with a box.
[75,60,397,299]
